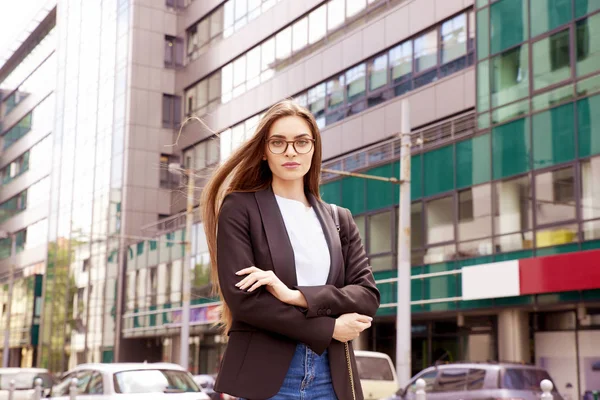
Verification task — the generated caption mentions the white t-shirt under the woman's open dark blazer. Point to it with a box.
[275,195,331,286]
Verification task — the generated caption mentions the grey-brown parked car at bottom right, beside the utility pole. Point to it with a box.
[386,363,564,400]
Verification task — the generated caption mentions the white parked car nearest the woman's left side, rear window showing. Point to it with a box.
[50,363,210,400]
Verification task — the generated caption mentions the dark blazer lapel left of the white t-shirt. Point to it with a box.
[254,187,298,287]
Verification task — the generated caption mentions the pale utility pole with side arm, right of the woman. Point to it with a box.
[321,99,412,387]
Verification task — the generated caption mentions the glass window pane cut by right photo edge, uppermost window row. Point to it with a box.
[575,14,600,76]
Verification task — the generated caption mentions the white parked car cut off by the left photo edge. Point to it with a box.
[0,368,55,400]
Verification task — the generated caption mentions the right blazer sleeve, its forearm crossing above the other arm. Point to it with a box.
[296,208,380,318]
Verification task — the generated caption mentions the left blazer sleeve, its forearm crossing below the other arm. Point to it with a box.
[217,193,335,354]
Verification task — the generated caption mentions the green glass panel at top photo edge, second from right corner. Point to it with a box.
[530,0,573,37]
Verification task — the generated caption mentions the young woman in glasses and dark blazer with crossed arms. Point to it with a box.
[202,101,379,400]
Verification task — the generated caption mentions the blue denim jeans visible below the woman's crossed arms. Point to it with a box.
[243,344,337,400]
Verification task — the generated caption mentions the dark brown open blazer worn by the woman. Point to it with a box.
[215,188,379,400]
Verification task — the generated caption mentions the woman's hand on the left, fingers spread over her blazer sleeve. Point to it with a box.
[235,266,308,308]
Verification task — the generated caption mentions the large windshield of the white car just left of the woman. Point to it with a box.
[114,369,200,393]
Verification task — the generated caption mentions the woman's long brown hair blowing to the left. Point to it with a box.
[201,100,322,331]
